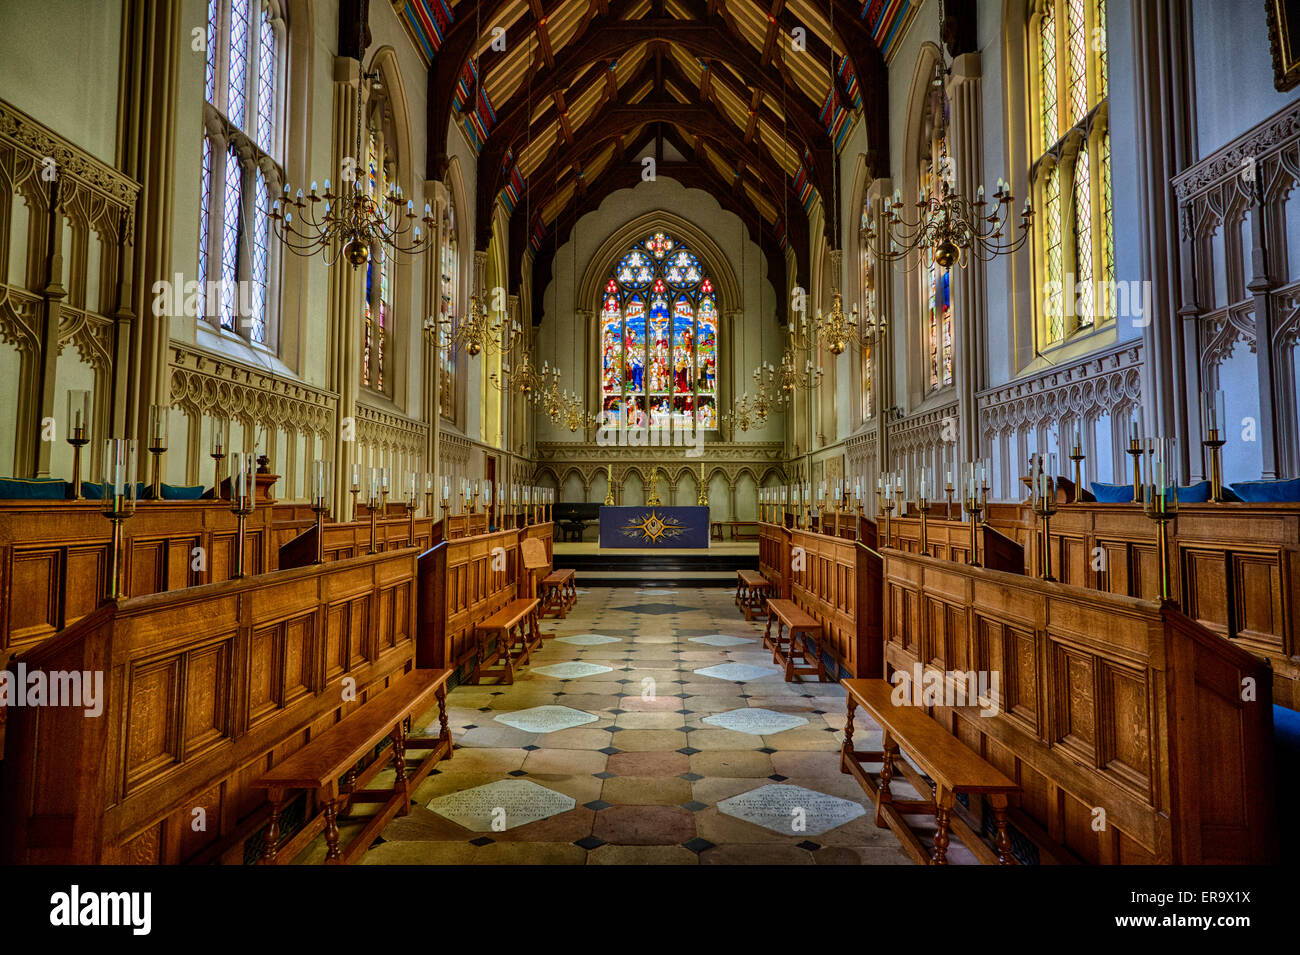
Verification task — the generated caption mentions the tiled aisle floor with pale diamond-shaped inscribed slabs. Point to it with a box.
[330,587,930,864]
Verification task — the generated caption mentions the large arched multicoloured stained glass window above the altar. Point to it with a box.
[601,233,718,430]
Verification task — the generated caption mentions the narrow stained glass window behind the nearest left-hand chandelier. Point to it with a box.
[361,96,397,394]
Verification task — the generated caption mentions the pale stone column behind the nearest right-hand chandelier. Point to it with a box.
[939,53,982,478]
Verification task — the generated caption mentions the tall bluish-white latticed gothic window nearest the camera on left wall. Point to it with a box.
[198,0,285,346]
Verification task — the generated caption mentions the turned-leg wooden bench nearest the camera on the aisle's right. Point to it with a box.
[840,680,1021,865]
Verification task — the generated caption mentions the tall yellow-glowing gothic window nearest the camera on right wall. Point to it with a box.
[1028,0,1115,347]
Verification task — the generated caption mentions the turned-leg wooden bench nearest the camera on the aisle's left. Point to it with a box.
[252,669,452,865]
